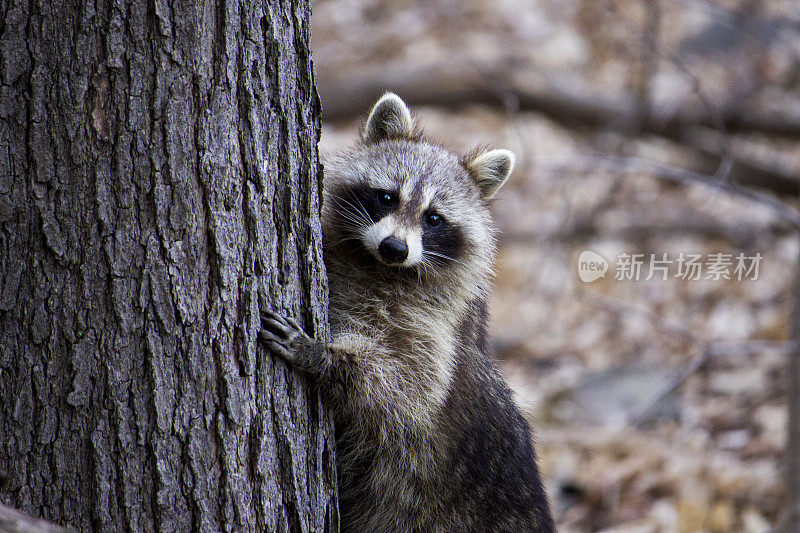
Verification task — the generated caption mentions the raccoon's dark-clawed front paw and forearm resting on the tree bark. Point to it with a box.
[258,310,350,386]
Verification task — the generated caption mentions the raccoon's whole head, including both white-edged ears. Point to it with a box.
[325,94,513,273]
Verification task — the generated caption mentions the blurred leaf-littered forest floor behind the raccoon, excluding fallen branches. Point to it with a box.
[312,0,800,533]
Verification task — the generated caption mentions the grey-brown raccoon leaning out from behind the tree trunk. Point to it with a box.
[259,93,554,532]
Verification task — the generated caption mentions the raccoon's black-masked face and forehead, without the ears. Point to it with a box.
[327,153,472,268]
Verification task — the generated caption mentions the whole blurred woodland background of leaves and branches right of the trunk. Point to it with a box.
[312,0,800,532]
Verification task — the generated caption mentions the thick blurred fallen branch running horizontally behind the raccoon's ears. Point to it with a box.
[317,56,800,140]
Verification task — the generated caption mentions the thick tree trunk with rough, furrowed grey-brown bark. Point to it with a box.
[0,0,338,531]
